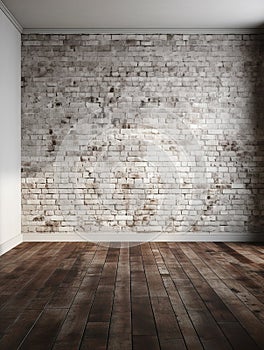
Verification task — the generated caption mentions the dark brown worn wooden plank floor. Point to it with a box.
[0,243,264,350]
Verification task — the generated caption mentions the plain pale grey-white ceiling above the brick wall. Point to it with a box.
[3,0,264,29]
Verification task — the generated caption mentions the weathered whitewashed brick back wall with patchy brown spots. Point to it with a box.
[22,34,264,239]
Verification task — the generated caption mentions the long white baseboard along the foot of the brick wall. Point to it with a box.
[23,232,264,242]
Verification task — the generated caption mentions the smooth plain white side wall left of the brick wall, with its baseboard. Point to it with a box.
[0,10,22,254]
